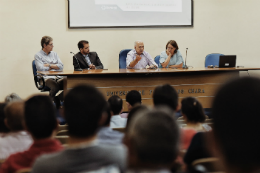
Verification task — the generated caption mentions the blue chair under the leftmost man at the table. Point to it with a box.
[32,60,50,92]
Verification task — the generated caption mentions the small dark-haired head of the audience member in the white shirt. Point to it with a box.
[108,95,123,115]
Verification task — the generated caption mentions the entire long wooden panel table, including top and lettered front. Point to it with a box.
[38,68,260,111]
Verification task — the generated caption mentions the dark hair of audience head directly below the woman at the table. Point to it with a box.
[153,84,178,111]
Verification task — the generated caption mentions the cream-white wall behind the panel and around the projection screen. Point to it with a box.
[0,0,260,101]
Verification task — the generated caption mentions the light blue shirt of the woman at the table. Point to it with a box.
[159,50,185,68]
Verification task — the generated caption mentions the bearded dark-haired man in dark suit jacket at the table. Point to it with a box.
[73,40,103,70]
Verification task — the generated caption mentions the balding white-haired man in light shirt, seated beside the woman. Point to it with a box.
[126,41,158,69]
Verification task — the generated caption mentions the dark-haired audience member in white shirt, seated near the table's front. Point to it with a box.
[108,95,127,128]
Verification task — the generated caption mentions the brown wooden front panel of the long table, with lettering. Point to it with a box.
[65,71,239,111]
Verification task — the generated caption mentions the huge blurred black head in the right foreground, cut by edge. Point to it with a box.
[212,77,260,172]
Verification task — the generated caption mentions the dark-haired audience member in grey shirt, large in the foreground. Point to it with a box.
[32,85,126,173]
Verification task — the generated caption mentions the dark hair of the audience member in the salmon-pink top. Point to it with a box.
[181,97,206,123]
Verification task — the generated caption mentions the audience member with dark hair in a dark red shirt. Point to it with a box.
[0,96,63,173]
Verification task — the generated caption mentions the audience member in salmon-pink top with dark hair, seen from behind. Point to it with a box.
[181,97,211,149]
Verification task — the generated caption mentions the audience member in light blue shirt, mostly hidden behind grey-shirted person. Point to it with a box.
[97,104,124,144]
